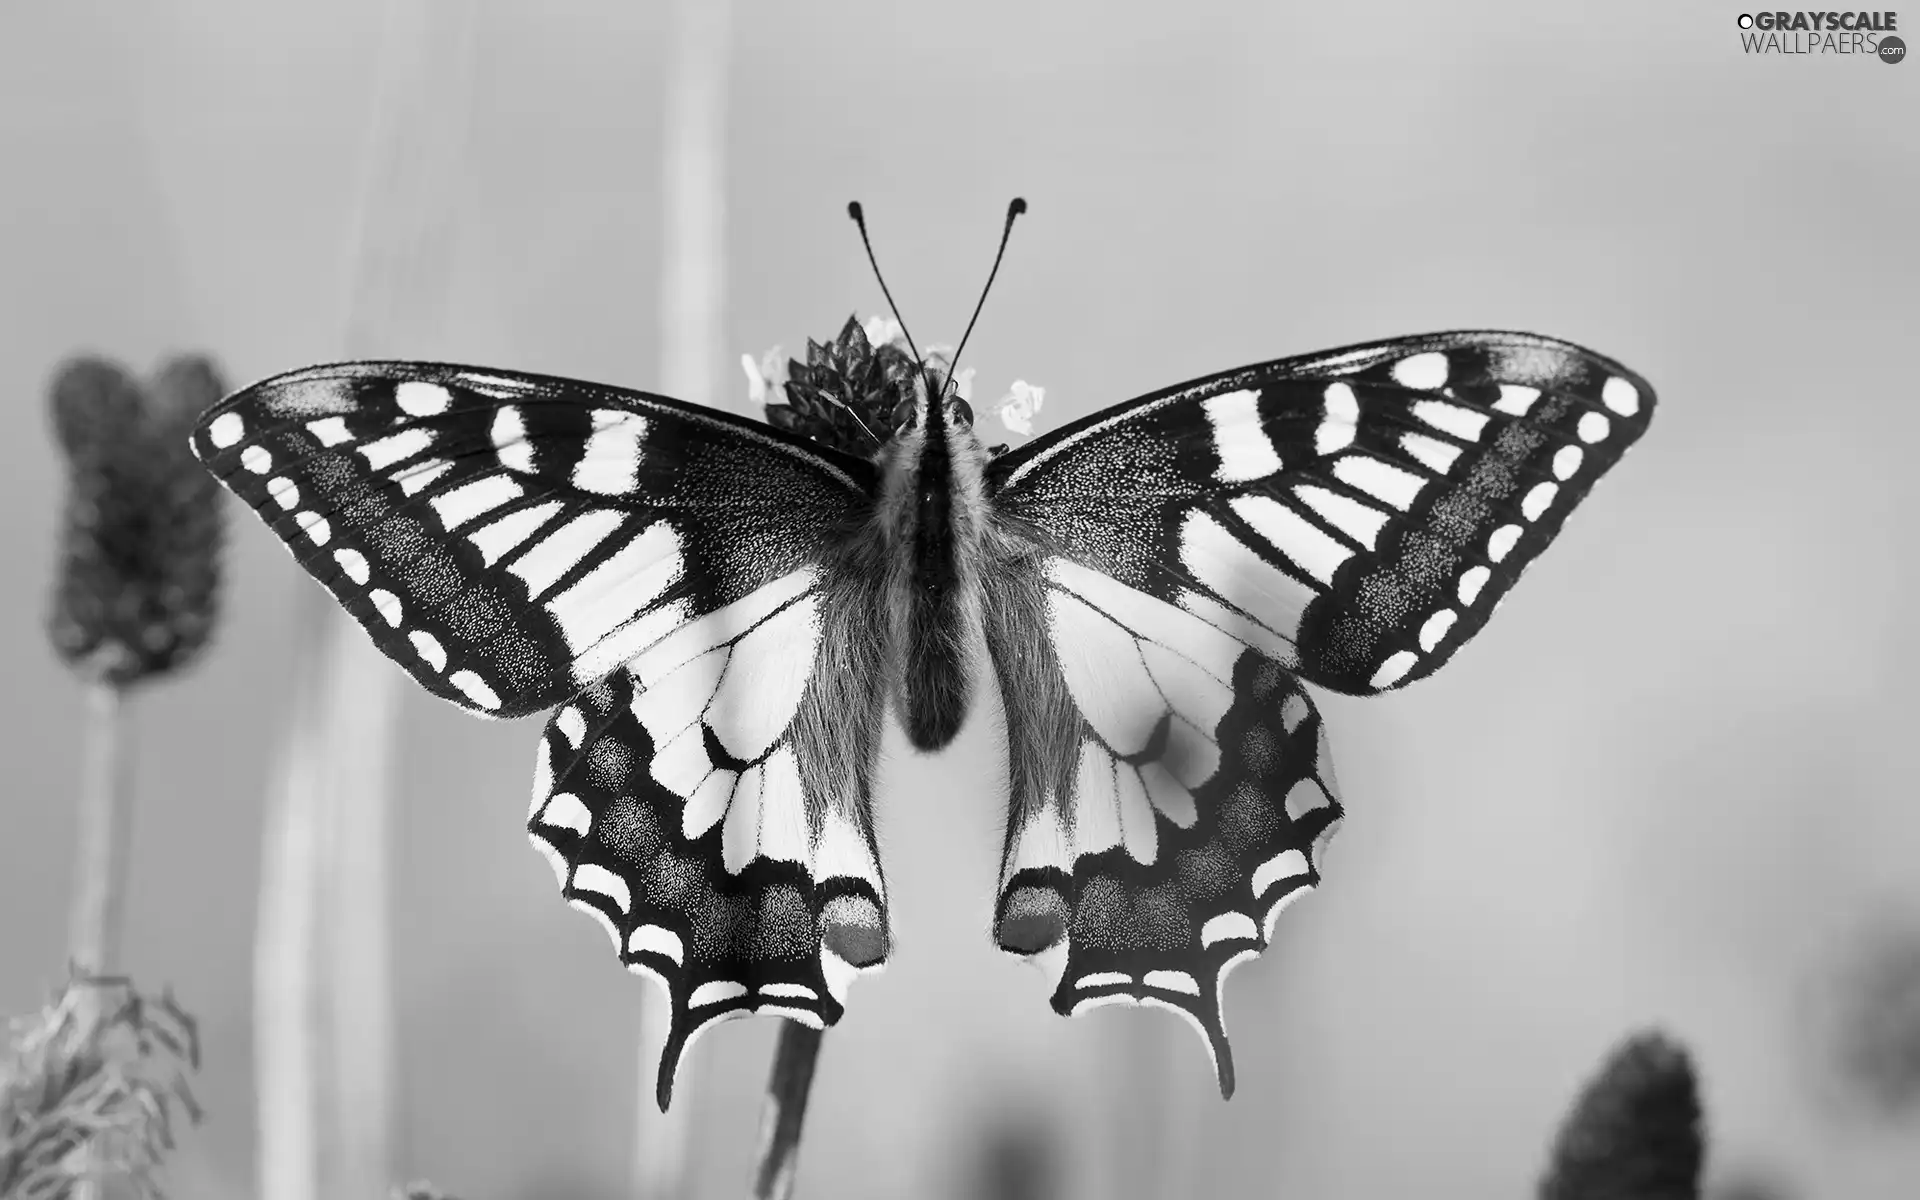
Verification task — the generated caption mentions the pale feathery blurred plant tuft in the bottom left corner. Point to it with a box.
[0,977,202,1200]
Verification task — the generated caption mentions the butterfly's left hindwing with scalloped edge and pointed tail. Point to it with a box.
[528,572,889,1110]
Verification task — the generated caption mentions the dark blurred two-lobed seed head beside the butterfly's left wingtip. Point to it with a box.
[48,355,227,687]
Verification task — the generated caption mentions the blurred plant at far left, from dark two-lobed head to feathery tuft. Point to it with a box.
[0,357,225,1200]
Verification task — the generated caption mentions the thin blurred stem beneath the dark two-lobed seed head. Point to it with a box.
[71,684,132,975]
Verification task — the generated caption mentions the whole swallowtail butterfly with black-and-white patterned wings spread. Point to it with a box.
[192,203,1655,1110]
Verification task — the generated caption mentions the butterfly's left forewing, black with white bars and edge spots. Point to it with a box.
[192,363,872,716]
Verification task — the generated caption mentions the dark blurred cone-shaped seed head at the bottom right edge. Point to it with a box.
[1540,1033,1707,1200]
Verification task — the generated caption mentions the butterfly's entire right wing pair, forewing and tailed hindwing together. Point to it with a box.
[987,332,1653,1092]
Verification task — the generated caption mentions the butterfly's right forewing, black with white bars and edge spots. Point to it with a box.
[989,332,1653,695]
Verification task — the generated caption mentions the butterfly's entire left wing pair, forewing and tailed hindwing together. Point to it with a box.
[194,363,889,1106]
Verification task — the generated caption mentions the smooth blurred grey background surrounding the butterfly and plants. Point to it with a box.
[0,0,1920,1200]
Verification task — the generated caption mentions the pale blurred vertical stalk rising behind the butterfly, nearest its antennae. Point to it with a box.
[634,0,732,1200]
